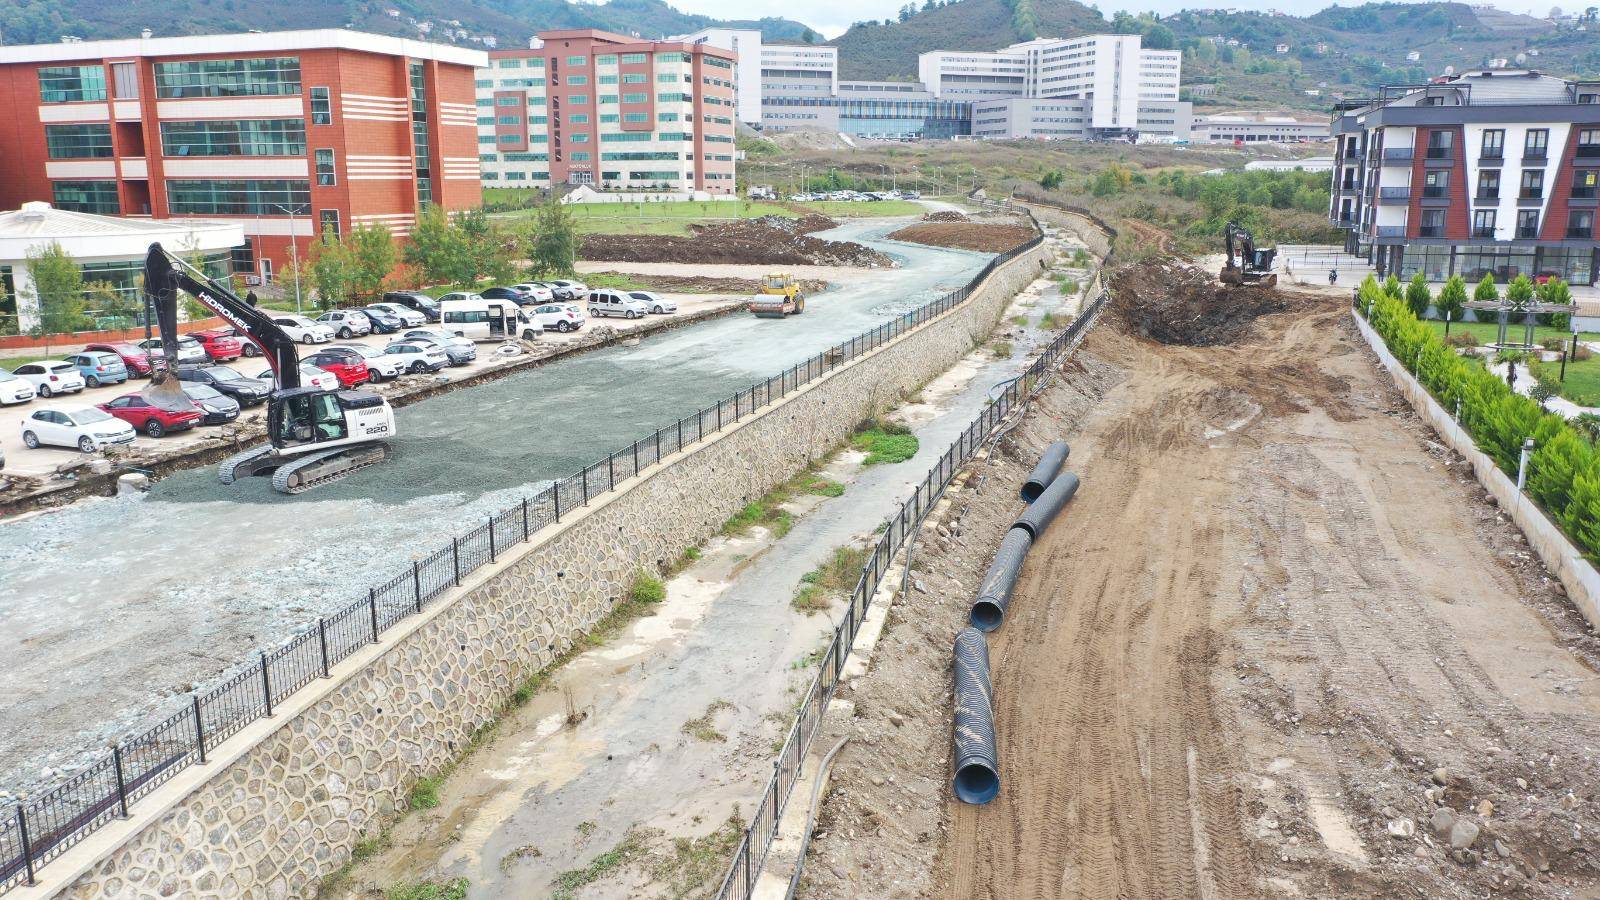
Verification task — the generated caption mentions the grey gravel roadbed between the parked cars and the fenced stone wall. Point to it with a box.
[0,221,987,790]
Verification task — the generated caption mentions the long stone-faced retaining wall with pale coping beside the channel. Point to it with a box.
[34,237,1050,898]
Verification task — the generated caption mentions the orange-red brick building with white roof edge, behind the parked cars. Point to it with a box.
[0,29,486,274]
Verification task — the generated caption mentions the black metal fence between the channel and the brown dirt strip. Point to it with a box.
[717,272,1106,900]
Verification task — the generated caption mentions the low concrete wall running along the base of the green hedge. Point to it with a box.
[1350,311,1600,628]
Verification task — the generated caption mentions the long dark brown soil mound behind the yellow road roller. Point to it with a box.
[581,216,894,269]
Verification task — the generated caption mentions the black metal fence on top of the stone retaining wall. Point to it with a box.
[0,201,1043,894]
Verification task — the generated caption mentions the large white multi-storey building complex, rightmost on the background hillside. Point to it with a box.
[917,34,1192,139]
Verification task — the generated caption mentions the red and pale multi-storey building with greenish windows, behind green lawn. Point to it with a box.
[477,29,738,194]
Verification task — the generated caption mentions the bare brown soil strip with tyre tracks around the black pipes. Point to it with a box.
[802,265,1600,898]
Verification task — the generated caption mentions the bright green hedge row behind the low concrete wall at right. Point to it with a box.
[1360,277,1600,562]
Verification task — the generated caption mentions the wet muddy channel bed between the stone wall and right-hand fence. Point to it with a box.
[348,264,1069,897]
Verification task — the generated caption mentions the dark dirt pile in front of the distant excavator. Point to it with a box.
[1110,259,1296,348]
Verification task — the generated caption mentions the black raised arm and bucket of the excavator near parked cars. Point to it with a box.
[142,243,301,410]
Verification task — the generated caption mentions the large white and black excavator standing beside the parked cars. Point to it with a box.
[141,243,395,493]
